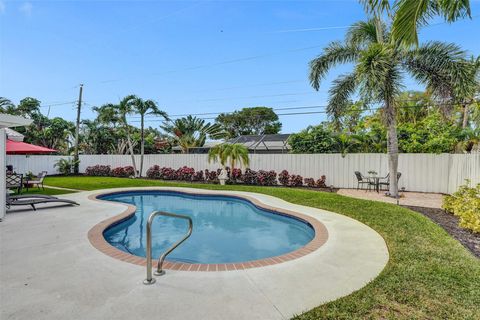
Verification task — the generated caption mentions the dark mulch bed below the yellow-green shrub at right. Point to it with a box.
[403,206,480,258]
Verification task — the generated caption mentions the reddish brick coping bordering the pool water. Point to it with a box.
[88,189,328,271]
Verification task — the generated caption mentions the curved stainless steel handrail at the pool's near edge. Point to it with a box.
[143,211,193,284]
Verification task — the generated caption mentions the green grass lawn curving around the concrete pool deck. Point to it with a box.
[45,177,480,319]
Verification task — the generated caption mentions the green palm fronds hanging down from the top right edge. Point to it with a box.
[360,0,471,46]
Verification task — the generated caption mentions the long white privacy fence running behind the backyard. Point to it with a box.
[7,153,480,193]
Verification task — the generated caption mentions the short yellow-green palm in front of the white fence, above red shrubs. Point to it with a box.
[208,143,250,171]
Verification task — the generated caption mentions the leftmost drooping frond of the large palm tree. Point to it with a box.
[309,42,358,90]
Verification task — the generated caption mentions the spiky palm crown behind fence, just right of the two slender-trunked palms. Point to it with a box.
[160,116,224,153]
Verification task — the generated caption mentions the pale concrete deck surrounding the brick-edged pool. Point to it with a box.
[0,187,388,319]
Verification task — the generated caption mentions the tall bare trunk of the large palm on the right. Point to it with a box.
[385,101,398,198]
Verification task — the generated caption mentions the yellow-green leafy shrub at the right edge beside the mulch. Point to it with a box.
[443,181,480,233]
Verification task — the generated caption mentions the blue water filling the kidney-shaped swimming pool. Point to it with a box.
[100,191,315,263]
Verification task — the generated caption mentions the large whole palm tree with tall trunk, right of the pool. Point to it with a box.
[310,17,471,197]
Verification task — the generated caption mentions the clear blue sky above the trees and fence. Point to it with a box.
[0,0,480,132]
